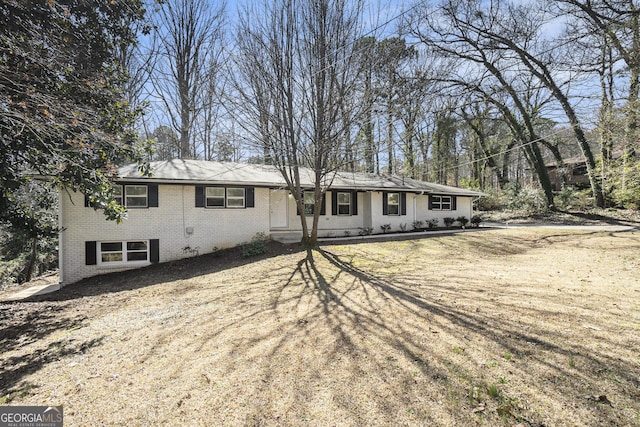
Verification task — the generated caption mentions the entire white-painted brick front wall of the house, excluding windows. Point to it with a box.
[59,185,472,285]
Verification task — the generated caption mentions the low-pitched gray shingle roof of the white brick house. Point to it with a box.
[118,159,482,196]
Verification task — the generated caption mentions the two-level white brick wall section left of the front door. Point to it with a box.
[59,185,269,285]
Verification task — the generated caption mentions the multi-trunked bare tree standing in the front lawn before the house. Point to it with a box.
[236,0,362,247]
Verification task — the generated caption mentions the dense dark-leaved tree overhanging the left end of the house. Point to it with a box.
[0,0,148,280]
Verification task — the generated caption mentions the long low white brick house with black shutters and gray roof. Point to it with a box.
[59,160,480,285]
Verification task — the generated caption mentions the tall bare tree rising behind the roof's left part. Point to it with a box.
[153,0,225,158]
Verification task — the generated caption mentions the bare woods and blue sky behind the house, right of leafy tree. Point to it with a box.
[135,0,640,208]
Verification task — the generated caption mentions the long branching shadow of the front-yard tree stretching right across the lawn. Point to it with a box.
[252,249,640,425]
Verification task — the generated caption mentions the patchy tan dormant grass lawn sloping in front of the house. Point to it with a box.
[0,229,640,426]
